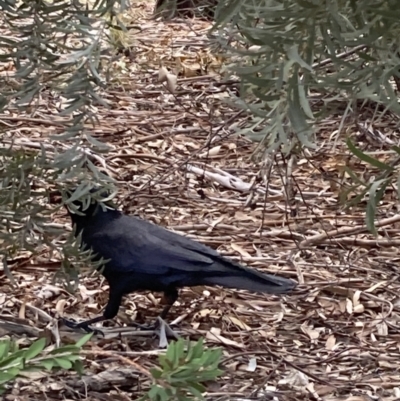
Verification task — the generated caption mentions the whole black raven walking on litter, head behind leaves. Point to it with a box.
[61,192,296,331]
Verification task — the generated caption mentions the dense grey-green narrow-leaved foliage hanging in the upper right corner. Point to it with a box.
[214,0,400,155]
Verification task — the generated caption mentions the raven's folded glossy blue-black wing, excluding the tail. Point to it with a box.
[86,215,223,274]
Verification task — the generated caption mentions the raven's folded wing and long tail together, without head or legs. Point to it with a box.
[87,215,294,293]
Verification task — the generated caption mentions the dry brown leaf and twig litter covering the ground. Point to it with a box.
[0,2,400,401]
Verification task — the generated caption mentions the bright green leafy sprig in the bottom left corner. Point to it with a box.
[0,334,92,394]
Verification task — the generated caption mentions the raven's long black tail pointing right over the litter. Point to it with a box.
[204,267,297,294]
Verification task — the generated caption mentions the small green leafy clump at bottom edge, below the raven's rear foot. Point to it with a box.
[141,339,222,401]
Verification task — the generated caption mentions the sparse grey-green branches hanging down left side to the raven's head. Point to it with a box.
[0,0,125,279]
